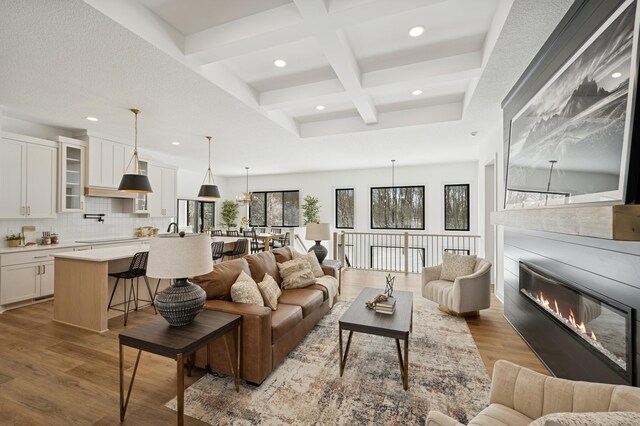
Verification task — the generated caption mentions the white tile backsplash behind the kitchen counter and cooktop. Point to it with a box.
[0,197,175,245]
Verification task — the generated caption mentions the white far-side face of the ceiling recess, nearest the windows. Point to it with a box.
[300,102,462,138]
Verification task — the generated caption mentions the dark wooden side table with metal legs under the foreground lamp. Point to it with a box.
[118,311,242,425]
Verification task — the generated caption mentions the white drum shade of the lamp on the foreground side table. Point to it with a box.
[147,234,213,278]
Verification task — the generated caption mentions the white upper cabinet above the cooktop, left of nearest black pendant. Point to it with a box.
[77,133,133,189]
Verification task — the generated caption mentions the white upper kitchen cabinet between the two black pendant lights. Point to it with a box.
[147,164,177,217]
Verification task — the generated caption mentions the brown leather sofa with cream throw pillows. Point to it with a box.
[190,247,338,384]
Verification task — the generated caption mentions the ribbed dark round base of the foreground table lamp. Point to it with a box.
[155,278,207,327]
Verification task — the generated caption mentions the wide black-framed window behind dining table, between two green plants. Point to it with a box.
[249,191,300,227]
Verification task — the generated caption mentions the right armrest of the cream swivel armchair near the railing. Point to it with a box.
[452,264,491,312]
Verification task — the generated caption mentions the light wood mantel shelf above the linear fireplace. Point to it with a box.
[491,204,640,241]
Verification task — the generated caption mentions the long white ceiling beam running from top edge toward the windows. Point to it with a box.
[294,0,378,124]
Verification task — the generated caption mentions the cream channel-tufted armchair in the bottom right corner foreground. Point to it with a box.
[427,360,640,426]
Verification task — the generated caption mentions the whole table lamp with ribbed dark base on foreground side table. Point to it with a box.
[147,232,213,326]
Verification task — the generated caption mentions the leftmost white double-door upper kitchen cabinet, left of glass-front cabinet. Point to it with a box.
[0,133,57,219]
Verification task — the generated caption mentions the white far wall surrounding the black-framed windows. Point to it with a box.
[222,162,478,234]
